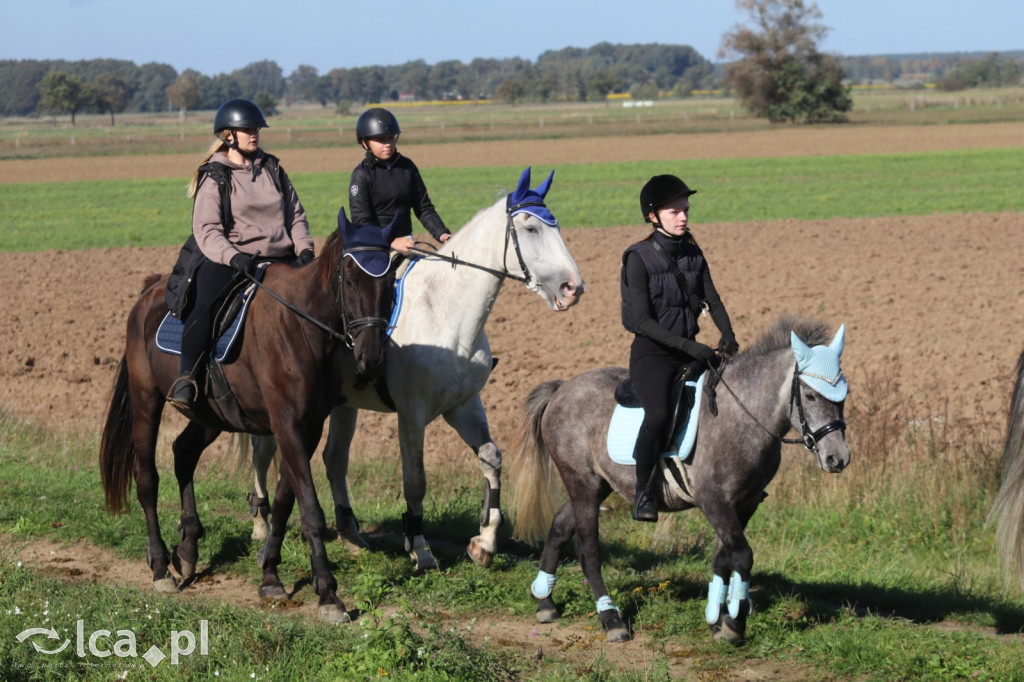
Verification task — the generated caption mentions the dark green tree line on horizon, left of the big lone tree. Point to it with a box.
[0,43,717,123]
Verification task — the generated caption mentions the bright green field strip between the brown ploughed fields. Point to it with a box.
[0,150,1024,252]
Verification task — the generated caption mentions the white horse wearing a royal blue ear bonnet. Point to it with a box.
[250,168,585,583]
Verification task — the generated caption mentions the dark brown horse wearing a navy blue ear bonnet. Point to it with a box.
[99,211,394,622]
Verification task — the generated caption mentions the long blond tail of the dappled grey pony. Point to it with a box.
[510,381,563,545]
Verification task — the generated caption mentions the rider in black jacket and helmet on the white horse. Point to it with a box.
[348,108,452,253]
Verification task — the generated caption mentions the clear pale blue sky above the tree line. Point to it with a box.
[0,0,1024,76]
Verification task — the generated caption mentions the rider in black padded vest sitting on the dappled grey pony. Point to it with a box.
[620,175,739,521]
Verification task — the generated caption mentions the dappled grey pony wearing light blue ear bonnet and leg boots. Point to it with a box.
[513,316,850,644]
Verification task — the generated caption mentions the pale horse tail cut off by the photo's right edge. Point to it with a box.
[988,346,1024,590]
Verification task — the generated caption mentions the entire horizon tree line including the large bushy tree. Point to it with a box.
[0,0,1024,125]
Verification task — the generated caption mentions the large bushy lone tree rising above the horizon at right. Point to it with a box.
[719,0,853,123]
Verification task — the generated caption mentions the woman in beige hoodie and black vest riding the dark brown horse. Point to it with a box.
[167,99,315,410]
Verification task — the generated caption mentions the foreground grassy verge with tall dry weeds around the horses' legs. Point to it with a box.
[0,367,1024,680]
